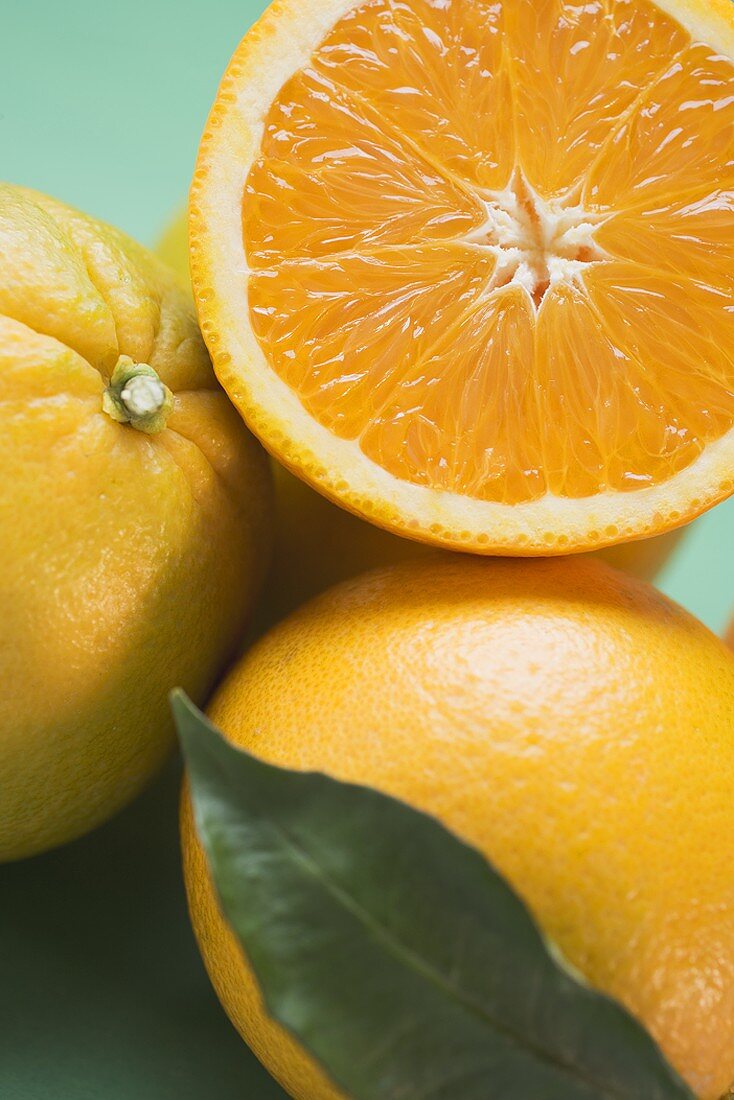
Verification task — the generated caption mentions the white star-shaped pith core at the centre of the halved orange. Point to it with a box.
[464,172,610,309]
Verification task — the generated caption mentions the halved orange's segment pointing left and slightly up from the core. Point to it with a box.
[243,69,483,266]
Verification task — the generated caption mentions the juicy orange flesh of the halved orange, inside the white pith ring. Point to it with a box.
[243,0,734,504]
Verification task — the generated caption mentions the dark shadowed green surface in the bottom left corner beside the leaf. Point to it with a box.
[0,760,285,1100]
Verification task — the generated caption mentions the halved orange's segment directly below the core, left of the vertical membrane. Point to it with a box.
[361,287,545,501]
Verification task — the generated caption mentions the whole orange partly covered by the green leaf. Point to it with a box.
[182,556,734,1100]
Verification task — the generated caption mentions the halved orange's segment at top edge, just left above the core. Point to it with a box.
[314,0,514,188]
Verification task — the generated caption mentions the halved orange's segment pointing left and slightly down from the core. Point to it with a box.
[250,245,494,439]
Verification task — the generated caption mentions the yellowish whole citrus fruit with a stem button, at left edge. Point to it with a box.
[0,185,271,859]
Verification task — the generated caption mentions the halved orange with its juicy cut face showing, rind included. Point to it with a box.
[190,0,734,553]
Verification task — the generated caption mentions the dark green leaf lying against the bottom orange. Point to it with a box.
[173,693,693,1100]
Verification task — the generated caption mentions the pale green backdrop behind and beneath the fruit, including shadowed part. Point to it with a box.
[0,0,734,1100]
